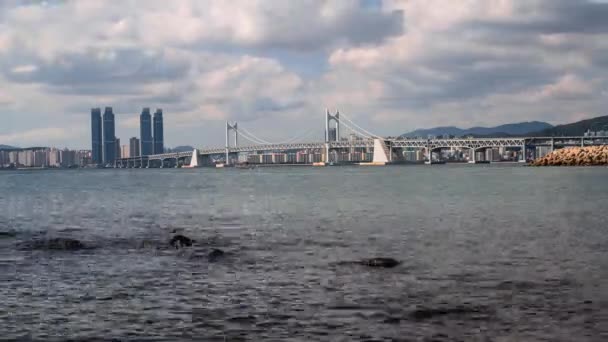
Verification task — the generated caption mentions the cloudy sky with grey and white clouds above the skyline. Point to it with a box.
[0,0,608,148]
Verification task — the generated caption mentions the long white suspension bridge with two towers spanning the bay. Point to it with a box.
[114,110,608,168]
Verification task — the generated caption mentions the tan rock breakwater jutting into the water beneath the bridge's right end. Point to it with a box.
[530,146,608,166]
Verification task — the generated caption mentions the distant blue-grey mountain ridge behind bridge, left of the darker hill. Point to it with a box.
[402,121,553,138]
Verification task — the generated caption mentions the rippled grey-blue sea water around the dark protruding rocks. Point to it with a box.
[0,164,608,341]
